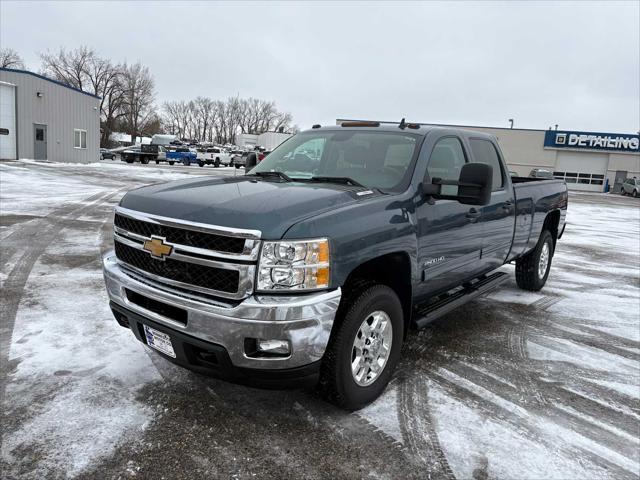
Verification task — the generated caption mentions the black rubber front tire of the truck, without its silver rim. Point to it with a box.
[319,285,404,410]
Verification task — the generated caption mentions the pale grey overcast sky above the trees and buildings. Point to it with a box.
[0,0,640,132]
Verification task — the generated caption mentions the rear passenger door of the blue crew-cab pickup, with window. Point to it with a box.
[468,137,515,270]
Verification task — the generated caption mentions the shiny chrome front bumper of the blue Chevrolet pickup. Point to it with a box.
[102,252,341,369]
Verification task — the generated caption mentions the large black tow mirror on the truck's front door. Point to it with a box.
[422,163,493,205]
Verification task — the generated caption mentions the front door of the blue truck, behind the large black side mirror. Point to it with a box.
[416,136,482,301]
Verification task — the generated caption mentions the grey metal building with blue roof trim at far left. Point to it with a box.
[0,68,100,162]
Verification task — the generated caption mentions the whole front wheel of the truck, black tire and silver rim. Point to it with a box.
[320,285,404,410]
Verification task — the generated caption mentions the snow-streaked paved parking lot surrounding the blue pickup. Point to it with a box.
[0,161,640,479]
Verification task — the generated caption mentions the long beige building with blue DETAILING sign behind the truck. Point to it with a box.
[337,119,640,192]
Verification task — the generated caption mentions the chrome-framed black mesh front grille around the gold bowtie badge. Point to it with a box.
[114,207,260,299]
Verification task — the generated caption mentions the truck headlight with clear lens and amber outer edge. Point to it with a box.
[257,238,329,291]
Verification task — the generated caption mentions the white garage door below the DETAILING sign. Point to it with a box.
[553,152,609,192]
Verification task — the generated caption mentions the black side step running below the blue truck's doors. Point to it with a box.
[415,272,509,328]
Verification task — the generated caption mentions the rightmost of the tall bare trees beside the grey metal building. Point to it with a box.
[122,62,155,141]
